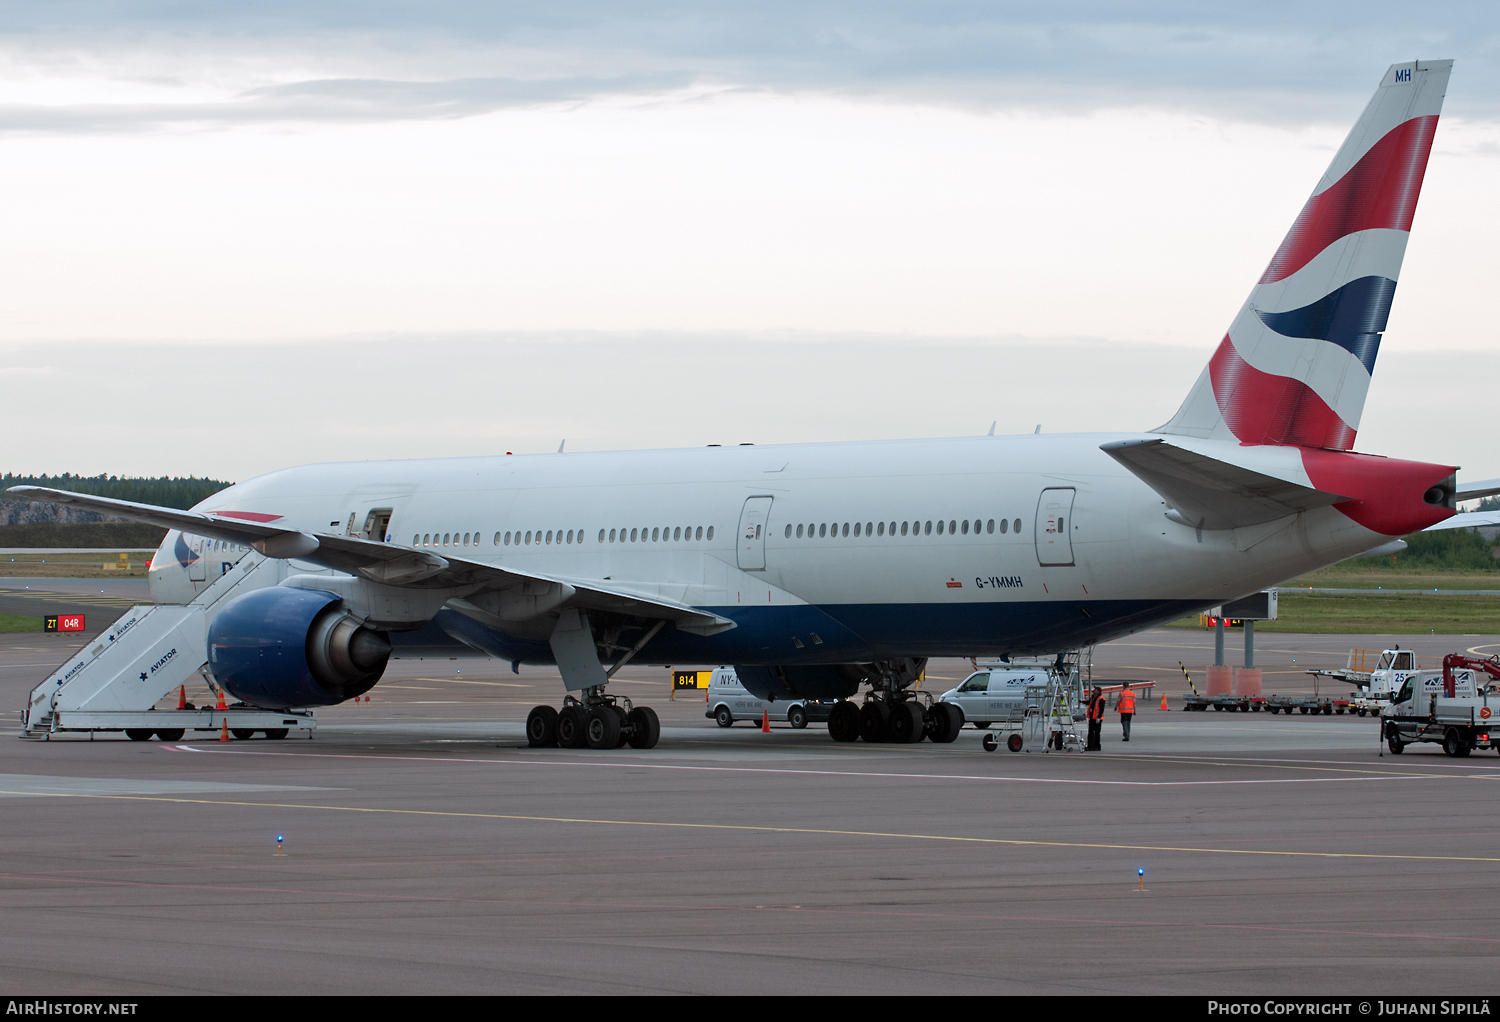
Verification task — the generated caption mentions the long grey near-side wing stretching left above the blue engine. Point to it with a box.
[6,486,735,635]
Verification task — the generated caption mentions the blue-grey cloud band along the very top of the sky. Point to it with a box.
[0,0,1500,132]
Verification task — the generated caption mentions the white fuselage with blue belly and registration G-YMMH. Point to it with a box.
[152,434,1385,663]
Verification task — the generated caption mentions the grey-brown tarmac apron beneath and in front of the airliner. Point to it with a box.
[0,618,1500,995]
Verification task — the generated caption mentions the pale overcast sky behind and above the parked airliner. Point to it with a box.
[0,0,1500,479]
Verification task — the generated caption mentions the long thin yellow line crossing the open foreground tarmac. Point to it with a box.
[0,791,1500,863]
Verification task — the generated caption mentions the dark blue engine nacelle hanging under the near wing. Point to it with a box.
[209,585,390,710]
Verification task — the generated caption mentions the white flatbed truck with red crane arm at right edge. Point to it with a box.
[1380,653,1500,756]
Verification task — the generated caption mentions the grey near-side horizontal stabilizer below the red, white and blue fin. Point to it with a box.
[1100,440,1350,530]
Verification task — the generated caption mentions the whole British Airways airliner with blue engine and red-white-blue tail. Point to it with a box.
[11,60,1481,749]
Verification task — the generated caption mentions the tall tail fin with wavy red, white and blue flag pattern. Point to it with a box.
[1155,60,1454,450]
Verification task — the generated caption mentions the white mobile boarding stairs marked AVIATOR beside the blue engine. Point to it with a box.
[21,552,317,741]
